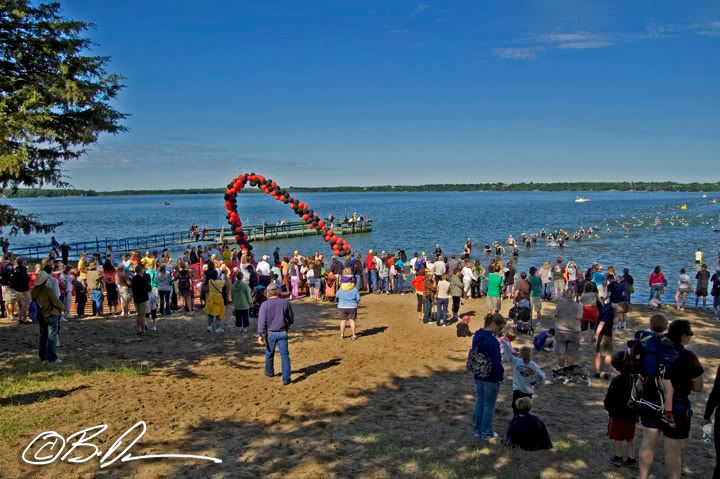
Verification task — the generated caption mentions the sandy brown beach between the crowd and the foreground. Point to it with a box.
[0,294,720,478]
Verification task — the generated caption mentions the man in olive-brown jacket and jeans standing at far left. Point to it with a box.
[32,270,63,364]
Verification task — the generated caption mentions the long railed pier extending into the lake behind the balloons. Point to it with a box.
[10,220,372,259]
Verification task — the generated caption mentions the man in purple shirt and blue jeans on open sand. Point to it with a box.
[258,283,295,386]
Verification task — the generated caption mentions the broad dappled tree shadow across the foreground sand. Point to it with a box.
[114,364,711,478]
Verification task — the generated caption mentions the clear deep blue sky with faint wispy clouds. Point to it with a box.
[63,0,720,190]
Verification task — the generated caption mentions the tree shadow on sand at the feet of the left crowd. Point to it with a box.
[0,302,337,378]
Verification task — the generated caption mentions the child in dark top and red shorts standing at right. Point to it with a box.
[604,351,637,467]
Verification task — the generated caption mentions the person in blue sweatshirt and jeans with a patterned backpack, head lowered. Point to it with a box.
[470,313,506,441]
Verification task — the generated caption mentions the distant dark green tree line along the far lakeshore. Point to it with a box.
[4,181,720,198]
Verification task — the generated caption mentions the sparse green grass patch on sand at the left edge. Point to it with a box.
[0,355,149,442]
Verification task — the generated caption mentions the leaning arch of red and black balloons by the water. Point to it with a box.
[225,173,352,256]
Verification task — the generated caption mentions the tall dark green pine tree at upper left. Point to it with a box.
[0,0,126,234]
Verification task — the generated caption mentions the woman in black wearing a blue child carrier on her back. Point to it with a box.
[640,319,704,479]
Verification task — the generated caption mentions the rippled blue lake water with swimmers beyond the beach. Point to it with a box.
[6,192,720,300]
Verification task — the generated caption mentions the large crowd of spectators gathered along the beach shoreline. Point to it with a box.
[0,237,720,477]
